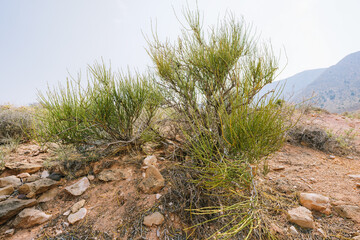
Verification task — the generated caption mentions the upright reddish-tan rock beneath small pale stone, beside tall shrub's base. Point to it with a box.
[139,165,165,194]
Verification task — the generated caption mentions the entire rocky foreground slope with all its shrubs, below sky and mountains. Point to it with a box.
[0,9,360,240]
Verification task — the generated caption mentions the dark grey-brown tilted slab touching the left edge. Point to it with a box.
[0,198,37,225]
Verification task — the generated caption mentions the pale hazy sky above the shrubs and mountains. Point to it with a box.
[0,0,360,105]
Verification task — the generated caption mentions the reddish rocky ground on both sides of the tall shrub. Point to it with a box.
[0,112,360,239]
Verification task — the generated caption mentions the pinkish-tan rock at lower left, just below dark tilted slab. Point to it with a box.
[12,208,52,228]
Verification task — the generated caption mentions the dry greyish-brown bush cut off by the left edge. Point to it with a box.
[0,106,33,144]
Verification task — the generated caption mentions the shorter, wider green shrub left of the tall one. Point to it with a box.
[39,63,161,145]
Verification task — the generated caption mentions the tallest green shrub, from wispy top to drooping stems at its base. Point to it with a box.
[149,10,291,239]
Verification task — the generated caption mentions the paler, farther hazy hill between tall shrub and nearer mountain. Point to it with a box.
[259,68,326,101]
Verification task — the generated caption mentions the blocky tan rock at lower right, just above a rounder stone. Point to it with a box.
[300,193,331,215]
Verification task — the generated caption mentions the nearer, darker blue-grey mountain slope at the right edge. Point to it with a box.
[295,52,360,113]
